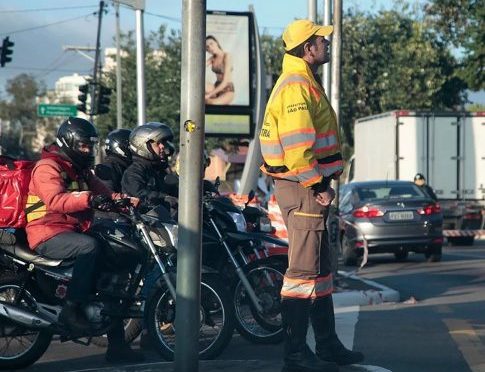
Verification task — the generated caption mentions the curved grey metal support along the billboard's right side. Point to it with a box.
[238,6,266,194]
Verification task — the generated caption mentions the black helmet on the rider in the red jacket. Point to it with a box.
[56,117,98,169]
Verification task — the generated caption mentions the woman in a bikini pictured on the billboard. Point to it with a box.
[205,35,234,105]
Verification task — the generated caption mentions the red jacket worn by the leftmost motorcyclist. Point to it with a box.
[25,145,118,249]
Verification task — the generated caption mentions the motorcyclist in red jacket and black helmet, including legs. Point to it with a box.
[26,117,144,362]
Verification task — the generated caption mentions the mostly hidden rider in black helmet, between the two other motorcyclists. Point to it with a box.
[94,129,131,192]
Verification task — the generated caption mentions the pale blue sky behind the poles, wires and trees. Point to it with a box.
[0,0,485,102]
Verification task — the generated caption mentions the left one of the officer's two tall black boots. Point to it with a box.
[281,298,338,372]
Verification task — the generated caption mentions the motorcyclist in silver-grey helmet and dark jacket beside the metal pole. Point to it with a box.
[121,122,178,215]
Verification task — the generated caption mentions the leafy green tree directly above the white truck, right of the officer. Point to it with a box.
[341,7,466,146]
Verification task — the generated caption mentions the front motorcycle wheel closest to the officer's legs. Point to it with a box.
[233,258,284,344]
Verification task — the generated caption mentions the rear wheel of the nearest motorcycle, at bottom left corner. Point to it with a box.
[0,273,52,370]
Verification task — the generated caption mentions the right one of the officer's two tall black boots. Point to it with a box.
[310,295,364,366]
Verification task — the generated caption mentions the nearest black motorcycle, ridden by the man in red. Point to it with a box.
[0,199,234,369]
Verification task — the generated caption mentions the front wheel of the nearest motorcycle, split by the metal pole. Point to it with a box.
[146,274,234,360]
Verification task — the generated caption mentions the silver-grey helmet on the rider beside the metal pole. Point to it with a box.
[130,122,175,162]
